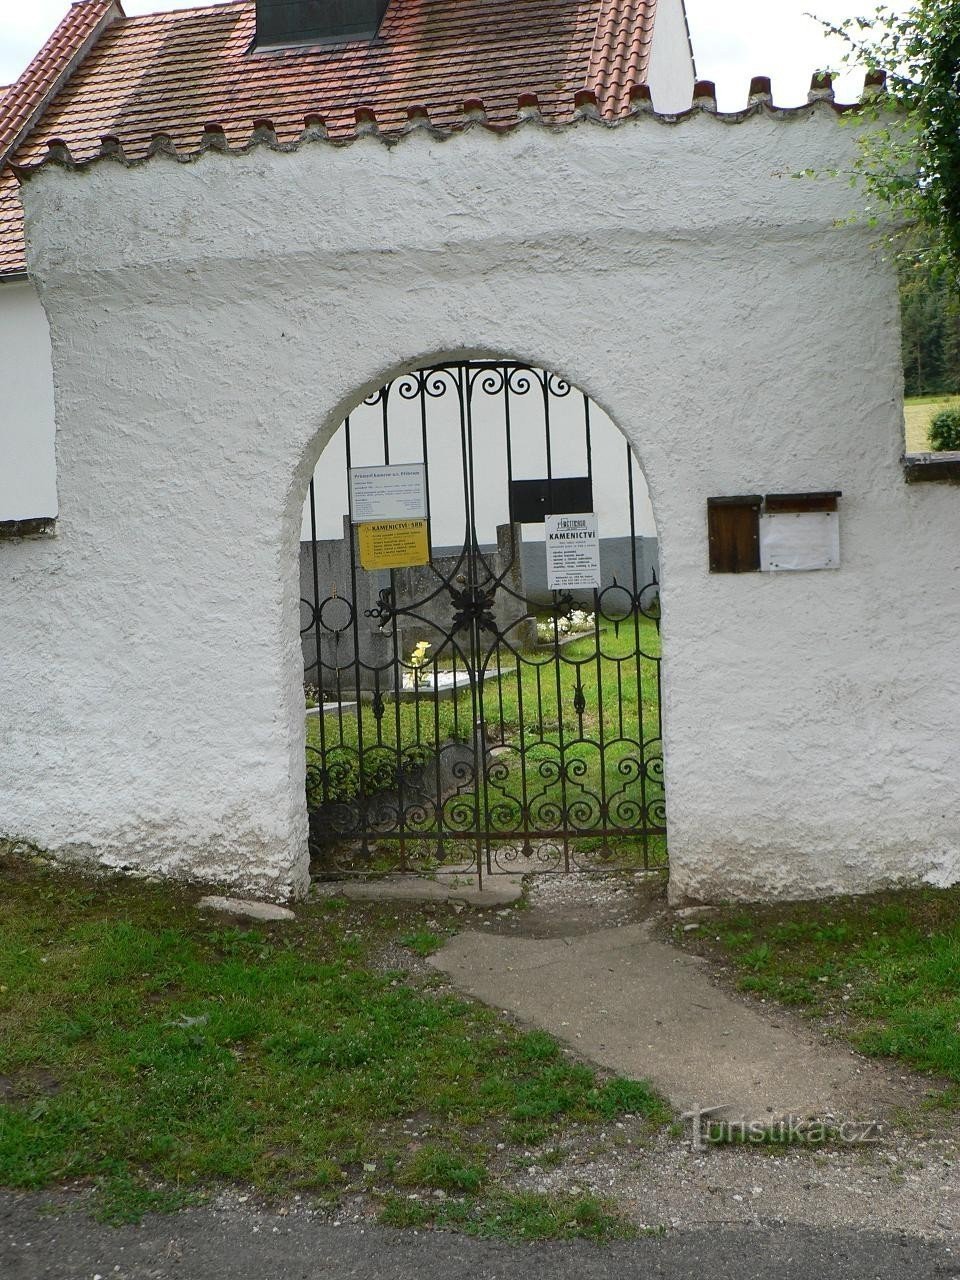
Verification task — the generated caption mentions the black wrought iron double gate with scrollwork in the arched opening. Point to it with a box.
[301,361,666,877]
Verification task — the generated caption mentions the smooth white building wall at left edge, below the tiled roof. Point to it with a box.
[0,282,56,521]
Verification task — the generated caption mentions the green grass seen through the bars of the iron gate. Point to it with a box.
[307,617,666,865]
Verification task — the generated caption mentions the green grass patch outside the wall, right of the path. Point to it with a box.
[687,888,960,1105]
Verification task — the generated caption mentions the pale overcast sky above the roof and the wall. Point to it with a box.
[0,0,910,110]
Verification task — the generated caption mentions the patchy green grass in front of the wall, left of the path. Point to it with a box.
[0,851,668,1238]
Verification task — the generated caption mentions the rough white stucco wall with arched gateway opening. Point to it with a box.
[0,105,960,899]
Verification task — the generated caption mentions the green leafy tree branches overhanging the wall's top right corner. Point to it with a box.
[826,0,960,292]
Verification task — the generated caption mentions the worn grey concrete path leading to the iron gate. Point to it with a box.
[431,922,913,1121]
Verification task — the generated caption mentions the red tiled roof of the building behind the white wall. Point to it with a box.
[0,0,657,275]
